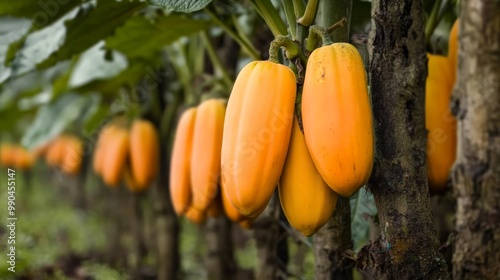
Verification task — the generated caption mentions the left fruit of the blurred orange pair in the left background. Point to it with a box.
[102,127,130,187]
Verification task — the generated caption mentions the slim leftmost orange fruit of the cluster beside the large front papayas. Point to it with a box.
[170,108,197,216]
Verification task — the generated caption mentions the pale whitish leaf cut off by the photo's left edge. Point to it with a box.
[0,17,31,83]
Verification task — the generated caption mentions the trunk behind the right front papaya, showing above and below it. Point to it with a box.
[313,0,352,280]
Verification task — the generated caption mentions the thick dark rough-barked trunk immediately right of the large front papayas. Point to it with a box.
[358,0,449,279]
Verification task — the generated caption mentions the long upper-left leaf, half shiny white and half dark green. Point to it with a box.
[7,0,146,75]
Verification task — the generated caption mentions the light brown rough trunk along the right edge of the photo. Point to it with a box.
[452,0,500,279]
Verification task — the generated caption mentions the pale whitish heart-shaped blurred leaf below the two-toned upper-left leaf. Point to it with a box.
[69,41,128,87]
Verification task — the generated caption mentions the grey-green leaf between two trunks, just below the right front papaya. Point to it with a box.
[350,187,377,252]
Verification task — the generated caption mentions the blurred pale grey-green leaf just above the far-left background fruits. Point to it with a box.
[21,93,101,148]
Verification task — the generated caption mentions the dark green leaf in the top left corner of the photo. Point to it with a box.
[0,0,82,29]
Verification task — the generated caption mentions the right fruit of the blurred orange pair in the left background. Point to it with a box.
[130,120,160,190]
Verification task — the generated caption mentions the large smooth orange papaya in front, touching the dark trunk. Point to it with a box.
[302,43,374,197]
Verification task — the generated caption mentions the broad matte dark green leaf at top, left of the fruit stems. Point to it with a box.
[106,14,210,60]
